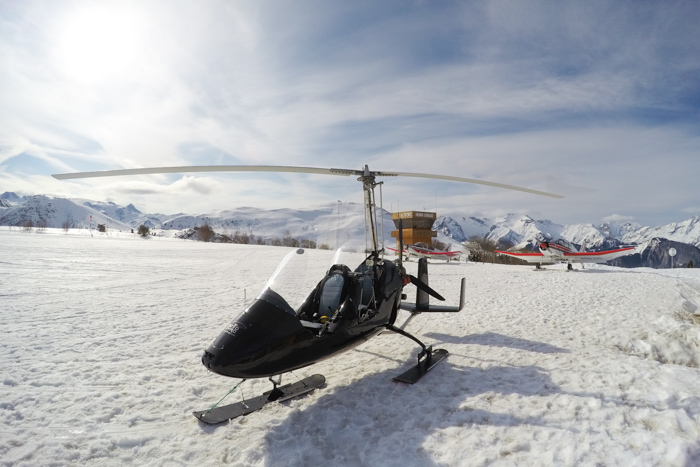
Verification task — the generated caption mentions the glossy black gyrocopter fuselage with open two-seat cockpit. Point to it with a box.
[202,249,410,378]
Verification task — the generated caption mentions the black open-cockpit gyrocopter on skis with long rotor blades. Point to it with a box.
[54,165,562,424]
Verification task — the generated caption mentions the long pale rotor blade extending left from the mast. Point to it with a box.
[52,165,362,180]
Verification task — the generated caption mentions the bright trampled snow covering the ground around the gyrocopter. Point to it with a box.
[0,228,700,466]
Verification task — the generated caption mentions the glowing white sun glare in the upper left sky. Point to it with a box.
[56,5,142,83]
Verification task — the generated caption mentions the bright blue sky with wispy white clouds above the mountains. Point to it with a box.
[0,0,700,226]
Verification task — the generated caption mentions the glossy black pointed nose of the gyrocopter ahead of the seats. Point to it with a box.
[202,299,313,378]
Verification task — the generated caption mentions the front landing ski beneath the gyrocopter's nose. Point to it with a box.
[192,375,326,425]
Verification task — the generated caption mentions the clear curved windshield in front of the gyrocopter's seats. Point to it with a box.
[258,247,365,310]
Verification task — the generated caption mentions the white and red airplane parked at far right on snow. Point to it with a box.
[496,235,637,270]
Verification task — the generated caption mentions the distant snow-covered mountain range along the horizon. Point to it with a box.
[0,192,700,267]
